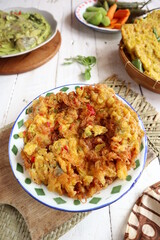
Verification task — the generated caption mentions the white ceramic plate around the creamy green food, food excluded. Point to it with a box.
[0,7,57,58]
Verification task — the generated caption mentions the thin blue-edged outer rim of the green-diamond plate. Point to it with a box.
[8,83,148,212]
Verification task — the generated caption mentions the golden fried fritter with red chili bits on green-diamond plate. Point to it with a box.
[21,84,144,200]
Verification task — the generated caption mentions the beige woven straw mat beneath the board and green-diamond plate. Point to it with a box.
[0,75,160,240]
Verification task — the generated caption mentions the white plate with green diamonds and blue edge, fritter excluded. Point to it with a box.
[9,84,147,212]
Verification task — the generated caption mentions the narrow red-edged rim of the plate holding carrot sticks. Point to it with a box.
[74,0,121,33]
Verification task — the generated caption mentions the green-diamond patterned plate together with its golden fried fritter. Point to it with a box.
[9,84,147,212]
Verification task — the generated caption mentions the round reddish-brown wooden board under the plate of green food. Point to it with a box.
[0,31,61,75]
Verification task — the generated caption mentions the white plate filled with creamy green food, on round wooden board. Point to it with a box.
[0,7,57,58]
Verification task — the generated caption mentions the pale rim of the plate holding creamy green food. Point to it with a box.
[0,7,58,58]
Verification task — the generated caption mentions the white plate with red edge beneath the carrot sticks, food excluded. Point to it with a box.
[75,0,121,33]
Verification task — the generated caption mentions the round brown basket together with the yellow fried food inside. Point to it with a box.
[119,10,160,93]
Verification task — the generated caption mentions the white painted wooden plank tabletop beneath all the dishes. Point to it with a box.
[0,0,160,240]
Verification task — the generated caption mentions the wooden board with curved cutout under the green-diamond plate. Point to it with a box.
[0,125,156,240]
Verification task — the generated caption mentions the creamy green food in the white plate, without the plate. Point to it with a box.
[0,11,51,56]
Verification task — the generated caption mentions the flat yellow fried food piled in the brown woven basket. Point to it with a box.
[122,10,160,81]
